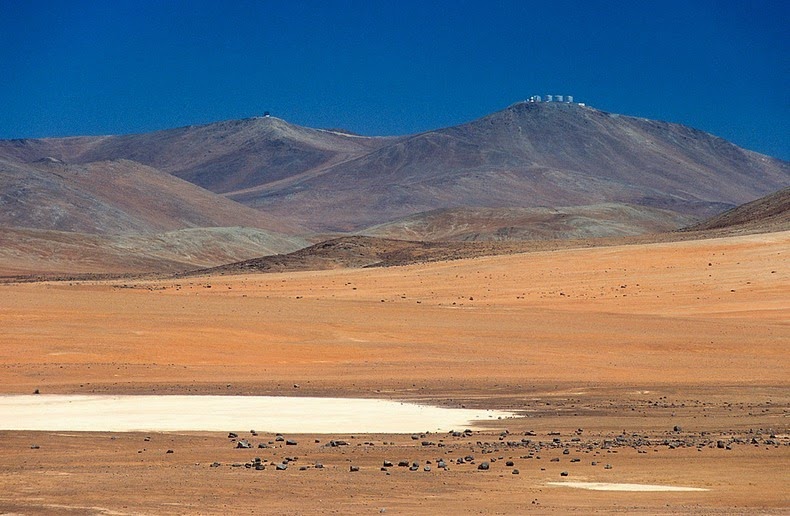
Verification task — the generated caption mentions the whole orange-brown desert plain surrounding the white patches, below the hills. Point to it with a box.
[0,232,790,514]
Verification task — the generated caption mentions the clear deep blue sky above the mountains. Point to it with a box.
[0,0,790,159]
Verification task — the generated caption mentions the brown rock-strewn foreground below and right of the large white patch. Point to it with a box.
[0,391,790,514]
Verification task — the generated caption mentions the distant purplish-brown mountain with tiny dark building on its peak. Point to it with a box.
[0,117,391,194]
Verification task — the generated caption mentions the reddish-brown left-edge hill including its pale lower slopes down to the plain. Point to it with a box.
[0,158,307,276]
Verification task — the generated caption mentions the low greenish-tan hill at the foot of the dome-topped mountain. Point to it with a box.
[360,203,694,241]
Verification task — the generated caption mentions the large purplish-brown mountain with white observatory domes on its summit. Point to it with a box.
[237,103,790,231]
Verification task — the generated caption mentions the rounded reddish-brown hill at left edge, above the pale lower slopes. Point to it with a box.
[0,158,296,234]
